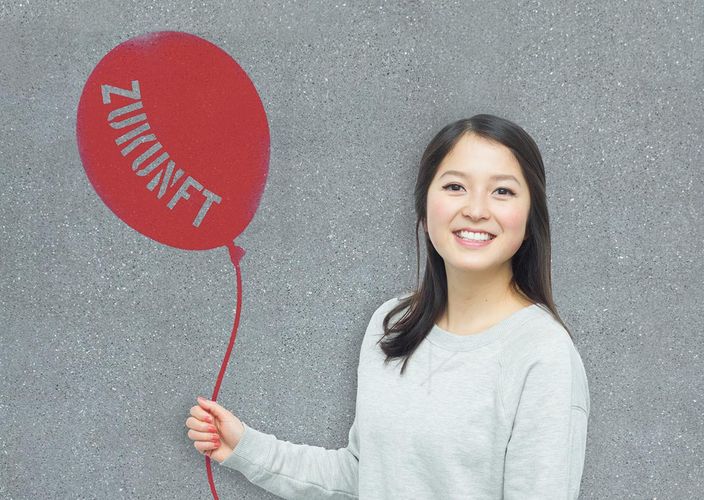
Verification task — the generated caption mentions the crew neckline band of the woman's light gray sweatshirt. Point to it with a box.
[426,303,542,351]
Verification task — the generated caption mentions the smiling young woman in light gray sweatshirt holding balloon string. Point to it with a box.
[186,114,590,500]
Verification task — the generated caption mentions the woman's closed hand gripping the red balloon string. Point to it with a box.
[186,397,244,463]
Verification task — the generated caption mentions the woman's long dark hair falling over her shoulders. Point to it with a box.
[379,114,573,375]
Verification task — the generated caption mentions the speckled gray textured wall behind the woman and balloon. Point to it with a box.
[0,0,704,499]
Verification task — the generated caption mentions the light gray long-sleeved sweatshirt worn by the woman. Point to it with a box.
[222,298,590,500]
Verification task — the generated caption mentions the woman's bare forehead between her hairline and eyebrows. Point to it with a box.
[437,134,523,179]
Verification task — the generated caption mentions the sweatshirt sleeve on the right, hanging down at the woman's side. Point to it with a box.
[504,339,589,500]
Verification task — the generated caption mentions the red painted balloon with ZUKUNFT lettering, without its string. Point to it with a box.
[76,31,269,250]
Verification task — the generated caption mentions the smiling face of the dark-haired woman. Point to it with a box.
[426,134,530,278]
